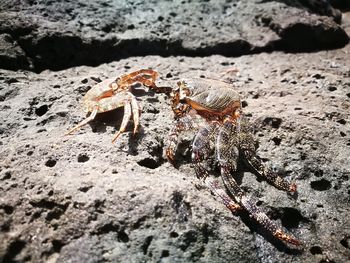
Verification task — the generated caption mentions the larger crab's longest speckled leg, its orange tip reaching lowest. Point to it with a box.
[216,122,301,248]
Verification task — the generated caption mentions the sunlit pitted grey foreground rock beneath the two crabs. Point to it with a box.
[0,46,350,262]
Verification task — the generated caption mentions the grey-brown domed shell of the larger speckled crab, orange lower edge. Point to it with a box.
[178,78,241,114]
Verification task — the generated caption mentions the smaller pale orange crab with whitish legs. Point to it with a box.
[65,69,170,143]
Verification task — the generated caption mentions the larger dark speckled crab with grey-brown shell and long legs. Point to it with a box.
[166,79,301,246]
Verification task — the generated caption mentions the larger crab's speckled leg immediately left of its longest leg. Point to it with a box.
[192,124,241,212]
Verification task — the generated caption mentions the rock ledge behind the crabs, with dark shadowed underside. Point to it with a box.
[0,0,349,72]
